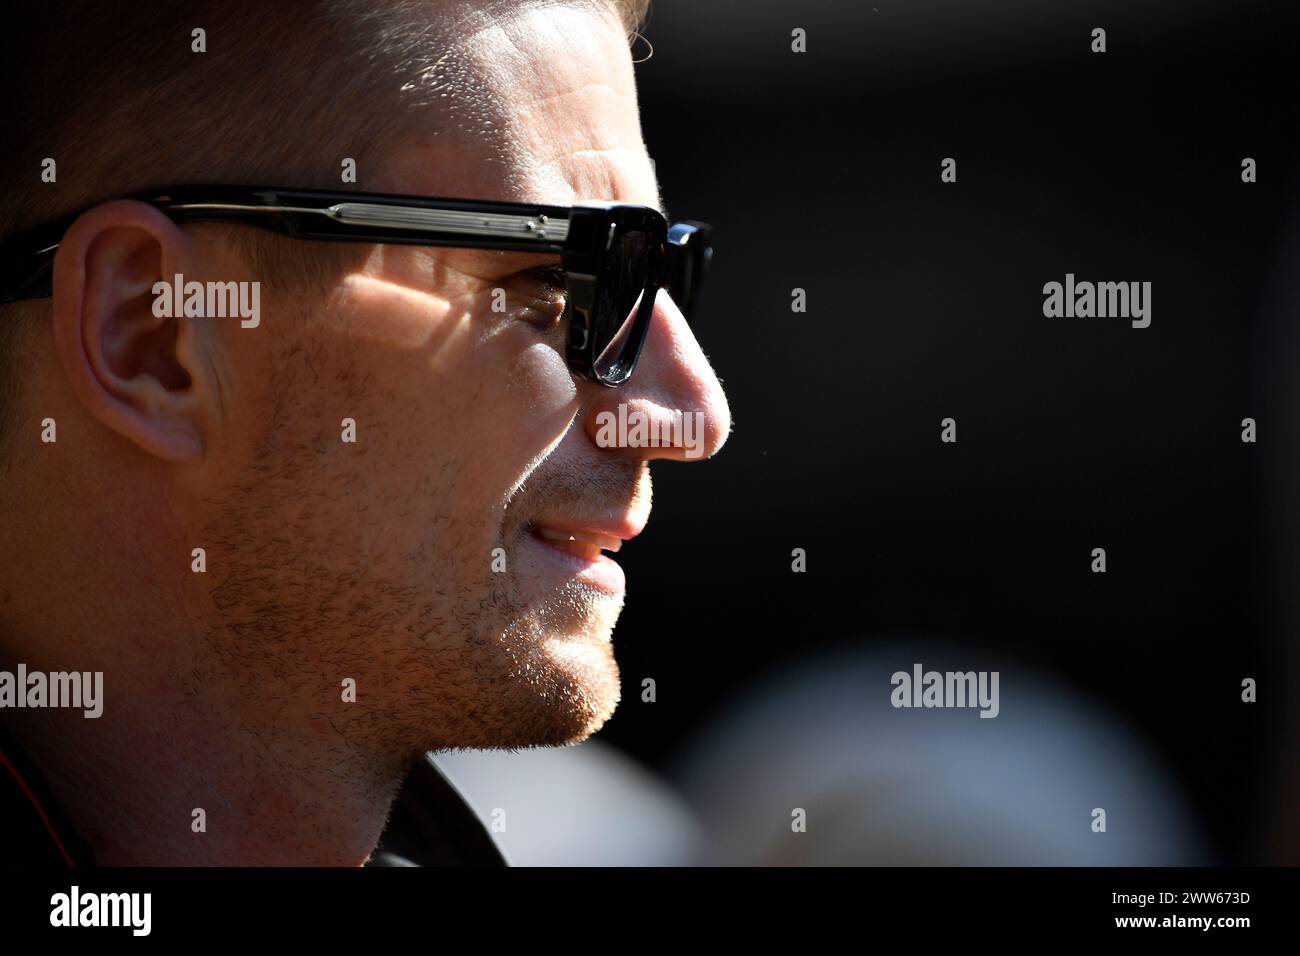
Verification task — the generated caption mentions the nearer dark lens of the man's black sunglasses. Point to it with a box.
[594,229,654,382]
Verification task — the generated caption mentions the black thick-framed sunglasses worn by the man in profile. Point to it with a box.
[0,186,712,388]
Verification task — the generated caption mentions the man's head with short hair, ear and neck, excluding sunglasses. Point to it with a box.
[0,0,731,864]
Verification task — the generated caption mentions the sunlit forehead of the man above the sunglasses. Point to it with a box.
[374,7,663,209]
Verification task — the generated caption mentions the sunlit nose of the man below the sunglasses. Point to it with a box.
[585,290,731,462]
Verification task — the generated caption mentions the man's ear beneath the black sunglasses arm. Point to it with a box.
[53,200,216,462]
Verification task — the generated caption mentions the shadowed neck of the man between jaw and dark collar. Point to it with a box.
[12,684,404,866]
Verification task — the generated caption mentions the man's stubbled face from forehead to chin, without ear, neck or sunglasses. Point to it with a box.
[179,4,729,754]
